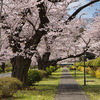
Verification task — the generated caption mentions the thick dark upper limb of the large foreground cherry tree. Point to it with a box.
[25,0,49,49]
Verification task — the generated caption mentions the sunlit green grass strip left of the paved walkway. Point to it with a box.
[8,68,62,100]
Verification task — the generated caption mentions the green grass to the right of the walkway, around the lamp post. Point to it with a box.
[70,71,100,100]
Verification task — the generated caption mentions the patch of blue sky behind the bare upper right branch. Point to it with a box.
[69,0,100,18]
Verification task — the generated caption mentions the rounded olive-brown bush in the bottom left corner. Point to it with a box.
[0,77,22,97]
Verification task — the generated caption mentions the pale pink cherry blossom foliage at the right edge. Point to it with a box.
[82,16,100,56]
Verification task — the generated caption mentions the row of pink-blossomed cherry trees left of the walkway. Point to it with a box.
[1,0,100,85]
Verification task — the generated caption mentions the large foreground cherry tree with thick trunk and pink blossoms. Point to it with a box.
[2,0,100,85]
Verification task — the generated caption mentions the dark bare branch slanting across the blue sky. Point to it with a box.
[65,0,100,24]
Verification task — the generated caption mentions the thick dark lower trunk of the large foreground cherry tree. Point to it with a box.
[11,56,31,85]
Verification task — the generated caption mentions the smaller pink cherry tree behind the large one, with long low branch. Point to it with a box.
[33,19,90,70]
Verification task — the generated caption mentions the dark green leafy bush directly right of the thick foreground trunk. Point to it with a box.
[28,69,42,86]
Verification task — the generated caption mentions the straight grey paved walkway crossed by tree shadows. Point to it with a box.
[55,68,90,100]
